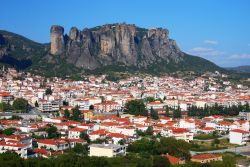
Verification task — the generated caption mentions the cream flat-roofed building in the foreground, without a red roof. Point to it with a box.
[89,144,126,157]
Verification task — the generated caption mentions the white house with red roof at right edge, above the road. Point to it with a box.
[229,129,250,145]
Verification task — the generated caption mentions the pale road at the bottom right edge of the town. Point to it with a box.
[190,145,250,155]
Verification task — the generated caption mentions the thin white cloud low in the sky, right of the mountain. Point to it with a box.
[188,47,225,56]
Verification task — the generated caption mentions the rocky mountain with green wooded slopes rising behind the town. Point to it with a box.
[0,24,224,76]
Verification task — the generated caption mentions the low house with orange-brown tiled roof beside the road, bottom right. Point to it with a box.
[191,153,222,163]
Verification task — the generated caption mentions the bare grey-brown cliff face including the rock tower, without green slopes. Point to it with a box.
[50,24,183,69]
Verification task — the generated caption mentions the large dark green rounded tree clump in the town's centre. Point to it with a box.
[125,100,148,116]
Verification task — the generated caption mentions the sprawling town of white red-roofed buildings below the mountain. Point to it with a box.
[0,67,250,165]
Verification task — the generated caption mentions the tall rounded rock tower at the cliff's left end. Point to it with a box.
[50,25,64,55]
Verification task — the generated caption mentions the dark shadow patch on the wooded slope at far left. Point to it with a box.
[0,55,32,70]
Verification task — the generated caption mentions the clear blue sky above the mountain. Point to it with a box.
[0,0,250,67]
